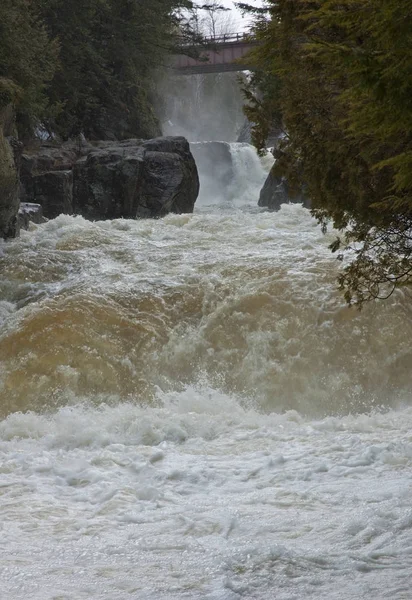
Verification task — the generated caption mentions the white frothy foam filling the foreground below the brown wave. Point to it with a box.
[0,387,412,600]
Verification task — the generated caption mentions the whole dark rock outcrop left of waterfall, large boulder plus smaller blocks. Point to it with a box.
[21,137,199,219]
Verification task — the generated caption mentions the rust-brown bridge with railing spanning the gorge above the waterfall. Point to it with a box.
[172,33,258,75]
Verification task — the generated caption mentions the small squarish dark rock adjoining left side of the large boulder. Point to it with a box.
[33,171,73,219]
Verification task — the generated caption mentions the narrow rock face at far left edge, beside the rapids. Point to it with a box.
[0,107,21,238]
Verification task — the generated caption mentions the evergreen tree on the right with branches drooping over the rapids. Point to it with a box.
[241,0,412,305]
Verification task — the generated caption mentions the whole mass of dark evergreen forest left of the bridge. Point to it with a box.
[0,0,211,140]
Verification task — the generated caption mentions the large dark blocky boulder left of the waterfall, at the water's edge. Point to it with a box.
[73,137,199,219]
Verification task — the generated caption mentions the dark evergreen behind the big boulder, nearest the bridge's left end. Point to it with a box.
[39,0,197,139]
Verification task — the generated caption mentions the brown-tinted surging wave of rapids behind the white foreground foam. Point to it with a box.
[0,205,411,416]
